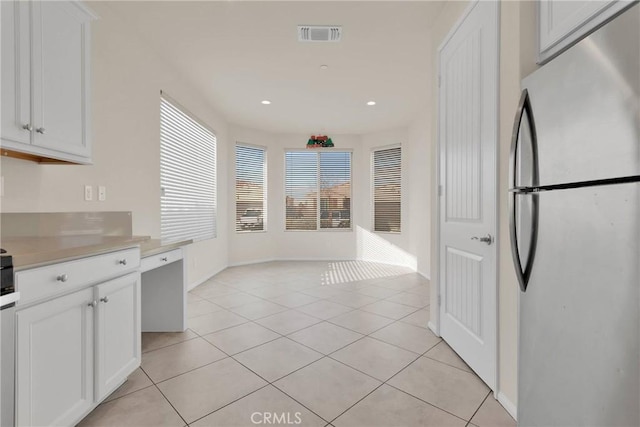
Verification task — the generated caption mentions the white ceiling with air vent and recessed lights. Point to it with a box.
[109,0,443,134]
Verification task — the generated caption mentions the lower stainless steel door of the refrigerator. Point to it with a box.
[518,184,640,426]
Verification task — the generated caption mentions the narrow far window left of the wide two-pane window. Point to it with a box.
[236,144,267,231]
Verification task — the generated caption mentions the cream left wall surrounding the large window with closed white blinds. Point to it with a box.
[0,2,229,284]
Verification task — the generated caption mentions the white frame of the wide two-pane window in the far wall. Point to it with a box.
[282,148,354,233]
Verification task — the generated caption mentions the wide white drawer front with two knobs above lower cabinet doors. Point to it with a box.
[15,248,140,305]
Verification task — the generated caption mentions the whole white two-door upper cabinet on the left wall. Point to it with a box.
[2,1,94,163]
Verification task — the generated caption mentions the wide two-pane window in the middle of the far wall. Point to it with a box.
[285,151,351,230]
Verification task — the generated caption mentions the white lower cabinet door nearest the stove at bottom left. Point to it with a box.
[16,289,94,426]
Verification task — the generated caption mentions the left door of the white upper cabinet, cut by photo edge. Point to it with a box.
[0,1,31,144]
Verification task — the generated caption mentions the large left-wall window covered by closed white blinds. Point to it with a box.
[160,97,216,242]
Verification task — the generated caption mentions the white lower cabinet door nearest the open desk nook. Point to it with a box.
[96,273,141,401]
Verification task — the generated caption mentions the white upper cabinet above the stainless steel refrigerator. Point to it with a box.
[538,0,634,64]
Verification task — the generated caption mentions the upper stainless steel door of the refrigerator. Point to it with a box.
[522,5,640,189]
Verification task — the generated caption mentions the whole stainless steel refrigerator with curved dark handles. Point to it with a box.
[509,5,640,426]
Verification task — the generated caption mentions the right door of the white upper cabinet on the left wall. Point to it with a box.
[32,1,90,157]
